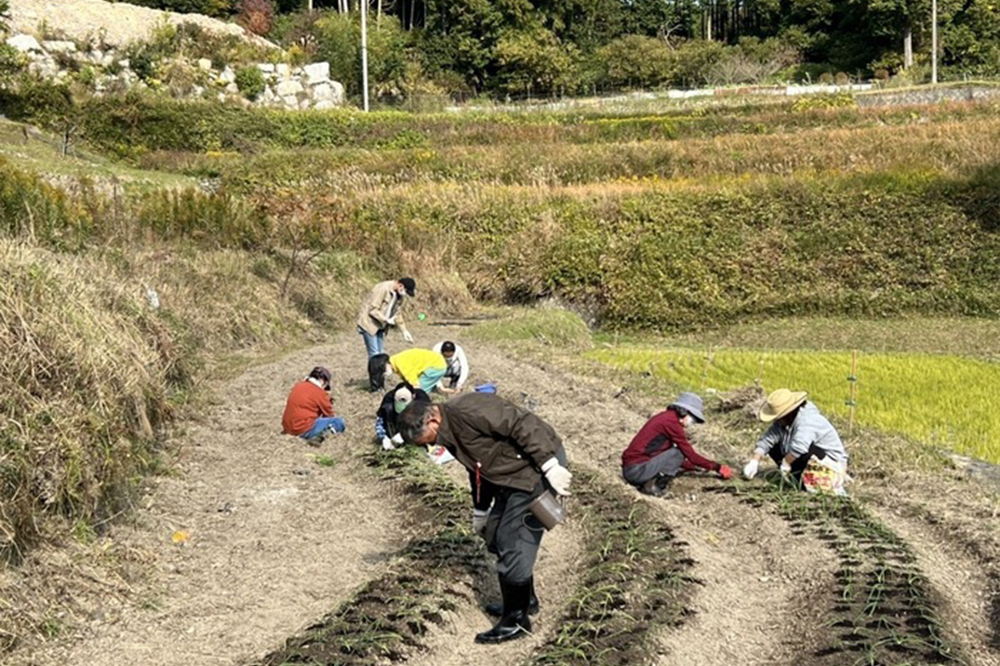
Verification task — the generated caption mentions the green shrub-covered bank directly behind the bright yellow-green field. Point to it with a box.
[330,171,1000,329]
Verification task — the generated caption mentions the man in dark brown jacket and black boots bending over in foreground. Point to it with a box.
[399,393,572,643]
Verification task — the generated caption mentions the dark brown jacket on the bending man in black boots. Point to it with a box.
[437,393,562,492]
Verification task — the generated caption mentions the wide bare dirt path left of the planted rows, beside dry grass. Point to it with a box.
[7,336,404,666]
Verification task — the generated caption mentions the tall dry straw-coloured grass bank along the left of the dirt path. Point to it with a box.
[0,241,414,556]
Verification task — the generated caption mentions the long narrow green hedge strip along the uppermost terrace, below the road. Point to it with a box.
[0,86,994,157]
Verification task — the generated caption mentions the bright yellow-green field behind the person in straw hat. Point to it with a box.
[585,346,1000,463]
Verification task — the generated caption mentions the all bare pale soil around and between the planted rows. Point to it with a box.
[11,327,1000,666]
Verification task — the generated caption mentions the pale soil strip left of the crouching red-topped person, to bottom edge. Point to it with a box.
[464,340,833,665]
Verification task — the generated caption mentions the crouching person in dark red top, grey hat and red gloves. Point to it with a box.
[622,393,733,497]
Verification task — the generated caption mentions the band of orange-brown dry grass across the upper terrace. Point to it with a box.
[213,118,1000,194]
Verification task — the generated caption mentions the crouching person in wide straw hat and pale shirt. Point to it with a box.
[743,389,847,484]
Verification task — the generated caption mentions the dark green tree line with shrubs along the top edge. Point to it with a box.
[115,0,1000,96]
